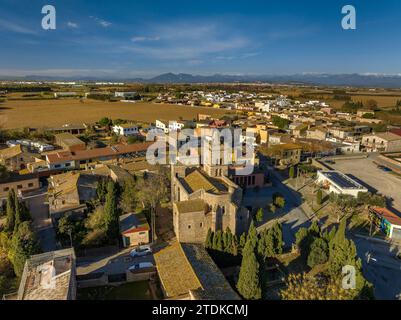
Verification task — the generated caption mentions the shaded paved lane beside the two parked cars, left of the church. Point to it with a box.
[77,248,155,275]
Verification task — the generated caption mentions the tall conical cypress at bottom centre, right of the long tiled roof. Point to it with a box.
[237,238,262,300]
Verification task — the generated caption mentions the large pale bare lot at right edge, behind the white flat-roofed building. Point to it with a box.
[324,154,401,211]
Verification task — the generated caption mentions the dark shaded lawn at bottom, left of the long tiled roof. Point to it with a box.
[78,281,152,300]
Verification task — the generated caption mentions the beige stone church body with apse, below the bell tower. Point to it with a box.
[171,166,249,243]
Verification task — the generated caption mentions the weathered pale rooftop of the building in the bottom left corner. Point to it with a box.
[18,249,76,300]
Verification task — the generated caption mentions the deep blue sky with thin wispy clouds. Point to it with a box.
[0,0,401,78]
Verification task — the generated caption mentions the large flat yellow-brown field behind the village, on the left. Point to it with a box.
[0,99,232,129]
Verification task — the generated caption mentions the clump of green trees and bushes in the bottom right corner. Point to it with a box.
[281,219,373,300]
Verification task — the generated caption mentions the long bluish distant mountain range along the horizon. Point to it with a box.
[0,73,401,88]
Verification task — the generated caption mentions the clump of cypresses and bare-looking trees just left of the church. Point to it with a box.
[57,168,168,247]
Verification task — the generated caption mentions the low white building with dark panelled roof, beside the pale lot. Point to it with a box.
[316,170,368,197]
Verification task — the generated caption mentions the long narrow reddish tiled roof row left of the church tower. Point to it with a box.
[46,142,153,164]
